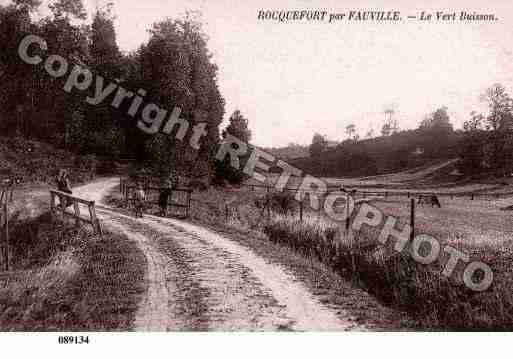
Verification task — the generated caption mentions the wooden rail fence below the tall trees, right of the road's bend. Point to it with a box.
[119,179,193,218]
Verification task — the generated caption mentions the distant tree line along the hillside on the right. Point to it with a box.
[304,84,513,177]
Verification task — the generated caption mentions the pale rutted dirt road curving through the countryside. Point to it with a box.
[74,178,365,331]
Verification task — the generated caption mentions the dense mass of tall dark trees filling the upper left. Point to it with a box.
[0,0,224,186]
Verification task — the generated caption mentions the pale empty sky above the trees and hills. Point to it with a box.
[4,0,513,147]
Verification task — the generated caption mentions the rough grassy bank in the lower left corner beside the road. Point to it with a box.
[0,214,146,331]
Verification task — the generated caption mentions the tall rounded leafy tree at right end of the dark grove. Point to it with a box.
[128,15,225,180]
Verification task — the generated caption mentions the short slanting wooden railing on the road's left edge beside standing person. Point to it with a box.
[50,190,103,236]
